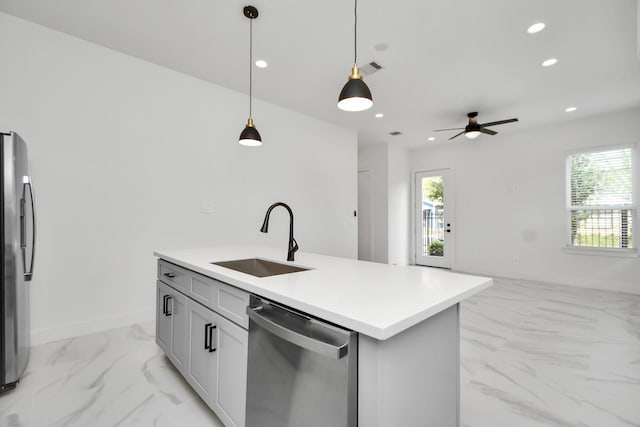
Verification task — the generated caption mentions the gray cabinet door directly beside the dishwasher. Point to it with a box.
[212,314,249,427]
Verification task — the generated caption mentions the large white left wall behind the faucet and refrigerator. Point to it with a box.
[0,13,357,343]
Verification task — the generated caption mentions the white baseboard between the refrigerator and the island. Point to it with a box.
[31,310,155,346]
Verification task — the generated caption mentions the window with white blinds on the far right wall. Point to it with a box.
[567,146,636,251]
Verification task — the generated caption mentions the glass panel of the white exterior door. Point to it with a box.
[421,175,445,257]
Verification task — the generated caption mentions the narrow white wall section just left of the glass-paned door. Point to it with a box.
[358,144,411,265]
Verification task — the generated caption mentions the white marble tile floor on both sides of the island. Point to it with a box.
[0,279,640,427]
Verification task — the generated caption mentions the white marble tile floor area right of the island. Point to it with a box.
[460,279,640,427]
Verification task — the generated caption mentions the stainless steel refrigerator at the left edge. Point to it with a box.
[0,132,36,392]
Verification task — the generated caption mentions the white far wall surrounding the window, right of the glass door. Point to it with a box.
[411,108,640,293]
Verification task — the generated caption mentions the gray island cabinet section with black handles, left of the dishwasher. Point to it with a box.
[156,260,249,427]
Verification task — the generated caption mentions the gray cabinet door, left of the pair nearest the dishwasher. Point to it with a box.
[186,301,218,406]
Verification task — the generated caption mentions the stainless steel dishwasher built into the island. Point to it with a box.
[246,295,358,427]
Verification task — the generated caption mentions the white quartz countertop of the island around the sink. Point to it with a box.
[154,246,492,340]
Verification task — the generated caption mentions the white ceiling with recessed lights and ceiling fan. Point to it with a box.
[0,0,640,147]
